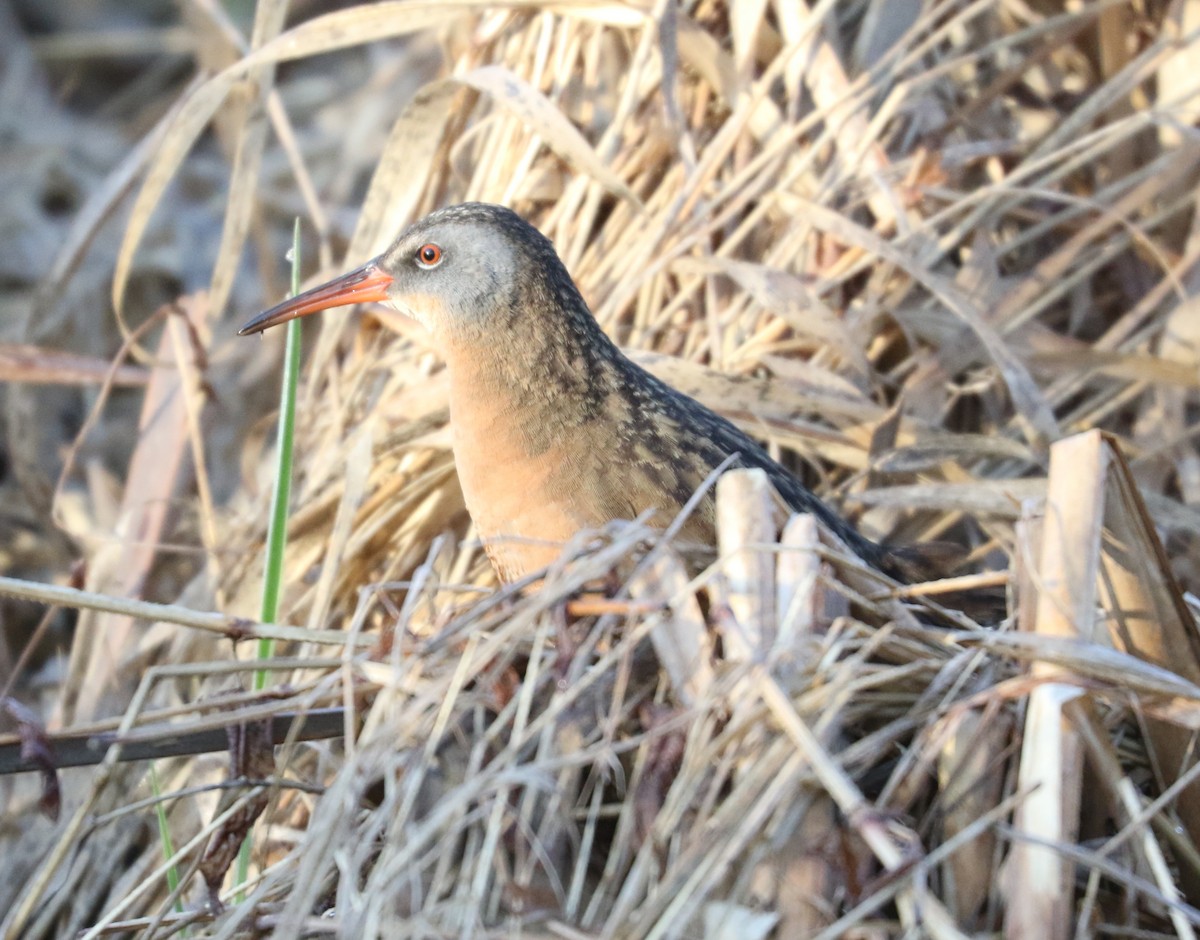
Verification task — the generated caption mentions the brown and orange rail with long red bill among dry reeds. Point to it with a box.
[239,203,895,583]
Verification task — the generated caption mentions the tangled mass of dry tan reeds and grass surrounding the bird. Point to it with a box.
[0,0,1200,940]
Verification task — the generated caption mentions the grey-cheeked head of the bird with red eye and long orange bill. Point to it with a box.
[239,203,577,341]
